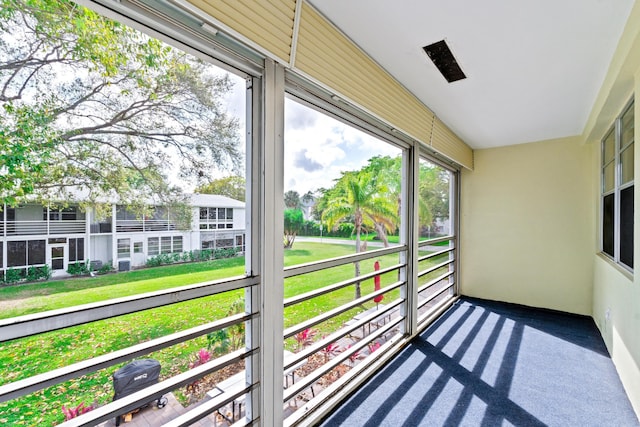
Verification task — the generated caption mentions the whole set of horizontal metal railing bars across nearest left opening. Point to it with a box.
[0,277,259,426]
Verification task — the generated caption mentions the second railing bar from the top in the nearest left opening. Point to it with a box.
[0,313,256,403]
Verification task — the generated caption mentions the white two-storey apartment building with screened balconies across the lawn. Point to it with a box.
[0,194,245,277]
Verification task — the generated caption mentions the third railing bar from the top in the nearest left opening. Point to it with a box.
[60,349,252,427]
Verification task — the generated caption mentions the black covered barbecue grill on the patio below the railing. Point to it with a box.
[113,359,167,426]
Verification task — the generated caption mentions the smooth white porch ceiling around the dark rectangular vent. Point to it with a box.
[310,0,634,148]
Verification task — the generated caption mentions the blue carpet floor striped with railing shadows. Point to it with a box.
[322,298,640,427]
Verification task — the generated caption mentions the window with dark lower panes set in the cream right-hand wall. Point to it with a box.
[601,98,635,269]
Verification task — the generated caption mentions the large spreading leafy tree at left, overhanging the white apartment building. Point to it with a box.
[0,0,242,204]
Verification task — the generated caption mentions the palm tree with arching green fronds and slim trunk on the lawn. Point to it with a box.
[322,171,397,299]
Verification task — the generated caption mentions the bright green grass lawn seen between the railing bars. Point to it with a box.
[0,242,444,426]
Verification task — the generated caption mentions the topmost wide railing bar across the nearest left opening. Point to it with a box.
[0,277,259,342]
